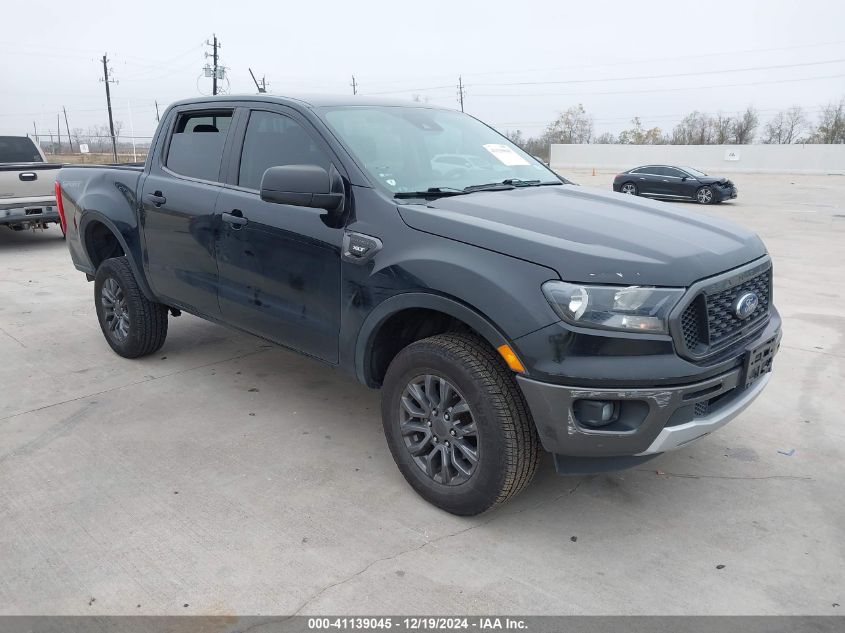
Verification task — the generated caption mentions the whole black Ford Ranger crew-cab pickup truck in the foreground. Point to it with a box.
[58,95,781,515]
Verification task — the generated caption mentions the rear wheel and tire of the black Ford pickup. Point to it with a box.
[94,257,167,358]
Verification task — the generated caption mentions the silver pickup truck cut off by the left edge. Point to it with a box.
[0,136,64,233]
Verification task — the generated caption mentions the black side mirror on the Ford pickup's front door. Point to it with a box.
[261,165,343,212]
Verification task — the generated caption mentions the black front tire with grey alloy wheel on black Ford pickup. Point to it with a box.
[381,333,540,516]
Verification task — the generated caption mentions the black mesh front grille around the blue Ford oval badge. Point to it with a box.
[678,267,772,358]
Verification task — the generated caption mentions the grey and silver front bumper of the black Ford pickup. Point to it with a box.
[517,327,781,471]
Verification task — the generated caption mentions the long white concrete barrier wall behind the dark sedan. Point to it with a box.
[550,145,845,174]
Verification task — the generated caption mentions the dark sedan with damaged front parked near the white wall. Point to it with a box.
[613,165,737,204]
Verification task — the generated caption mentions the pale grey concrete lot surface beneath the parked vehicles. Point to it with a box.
[0,173,845,614]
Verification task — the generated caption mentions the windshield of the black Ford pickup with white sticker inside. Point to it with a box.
[324,106,562,194]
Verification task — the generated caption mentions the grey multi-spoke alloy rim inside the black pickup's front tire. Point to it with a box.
[399,374,479,486]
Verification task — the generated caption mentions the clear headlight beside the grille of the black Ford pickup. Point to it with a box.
[543,281,684,334]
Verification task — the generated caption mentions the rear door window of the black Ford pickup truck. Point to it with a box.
[165,110,232,182]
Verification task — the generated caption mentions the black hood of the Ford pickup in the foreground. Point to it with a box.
[399,185,766,286]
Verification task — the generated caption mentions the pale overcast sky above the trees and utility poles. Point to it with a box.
[0,0,845,141]
